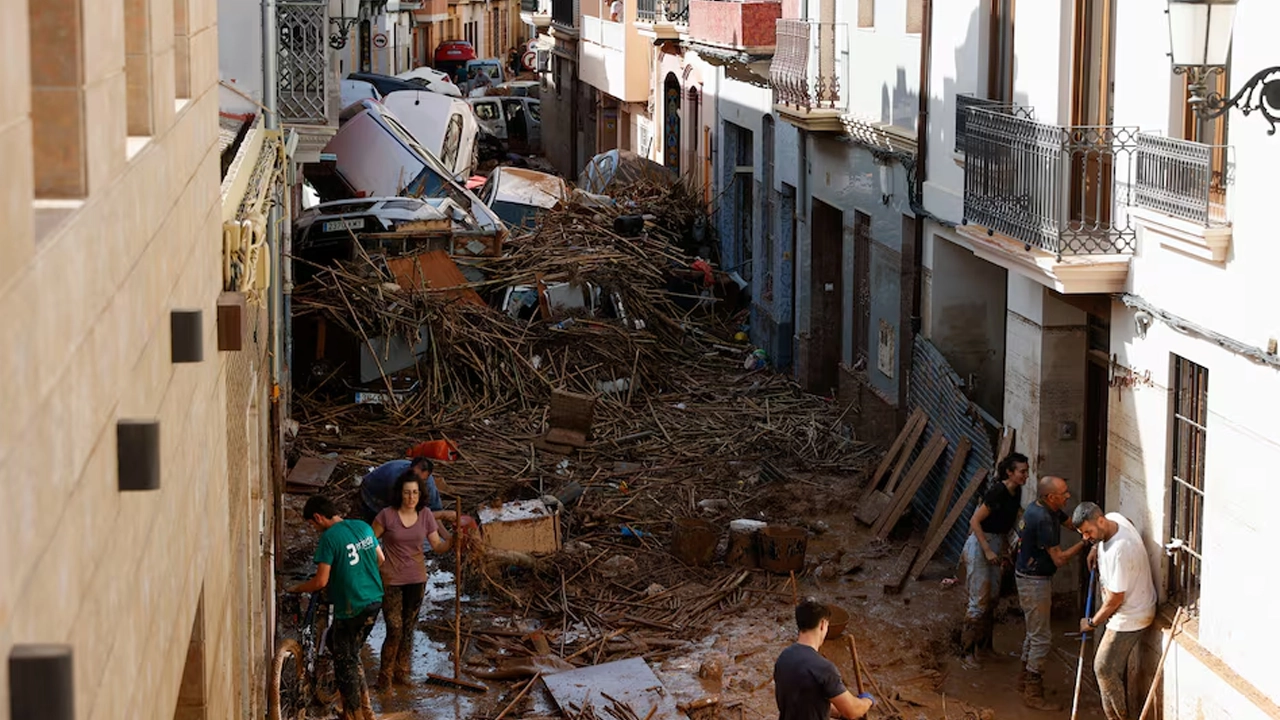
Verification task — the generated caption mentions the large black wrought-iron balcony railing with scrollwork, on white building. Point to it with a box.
[964,108,1138,258]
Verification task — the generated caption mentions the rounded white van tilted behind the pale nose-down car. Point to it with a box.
[383,90,480,179]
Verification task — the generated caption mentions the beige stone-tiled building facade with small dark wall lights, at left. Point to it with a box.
[0,0,278,719]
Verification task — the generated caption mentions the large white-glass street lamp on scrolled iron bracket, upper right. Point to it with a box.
[1169,0,1280,135]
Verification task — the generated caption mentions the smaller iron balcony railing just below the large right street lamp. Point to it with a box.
[1134,135,1231,228]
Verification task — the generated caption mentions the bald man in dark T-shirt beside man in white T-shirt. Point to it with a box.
[1014,475,1084,710]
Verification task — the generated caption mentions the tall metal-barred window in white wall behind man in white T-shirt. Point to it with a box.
[1169,355,1208,607]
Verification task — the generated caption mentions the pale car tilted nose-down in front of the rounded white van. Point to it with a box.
[307,100,506,234]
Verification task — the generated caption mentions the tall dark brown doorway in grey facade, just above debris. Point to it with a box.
[805,199,845,396]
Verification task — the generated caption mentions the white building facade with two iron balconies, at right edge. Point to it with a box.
[923,0,1280,717]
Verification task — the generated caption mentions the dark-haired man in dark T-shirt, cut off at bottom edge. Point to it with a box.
[773,597,874,720]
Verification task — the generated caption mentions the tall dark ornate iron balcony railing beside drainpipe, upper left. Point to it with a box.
[275,0,329,126]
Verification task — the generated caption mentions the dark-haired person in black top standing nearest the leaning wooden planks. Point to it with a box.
[960,452,1030,670]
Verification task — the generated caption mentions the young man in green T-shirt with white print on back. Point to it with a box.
[289,495,384,720]
